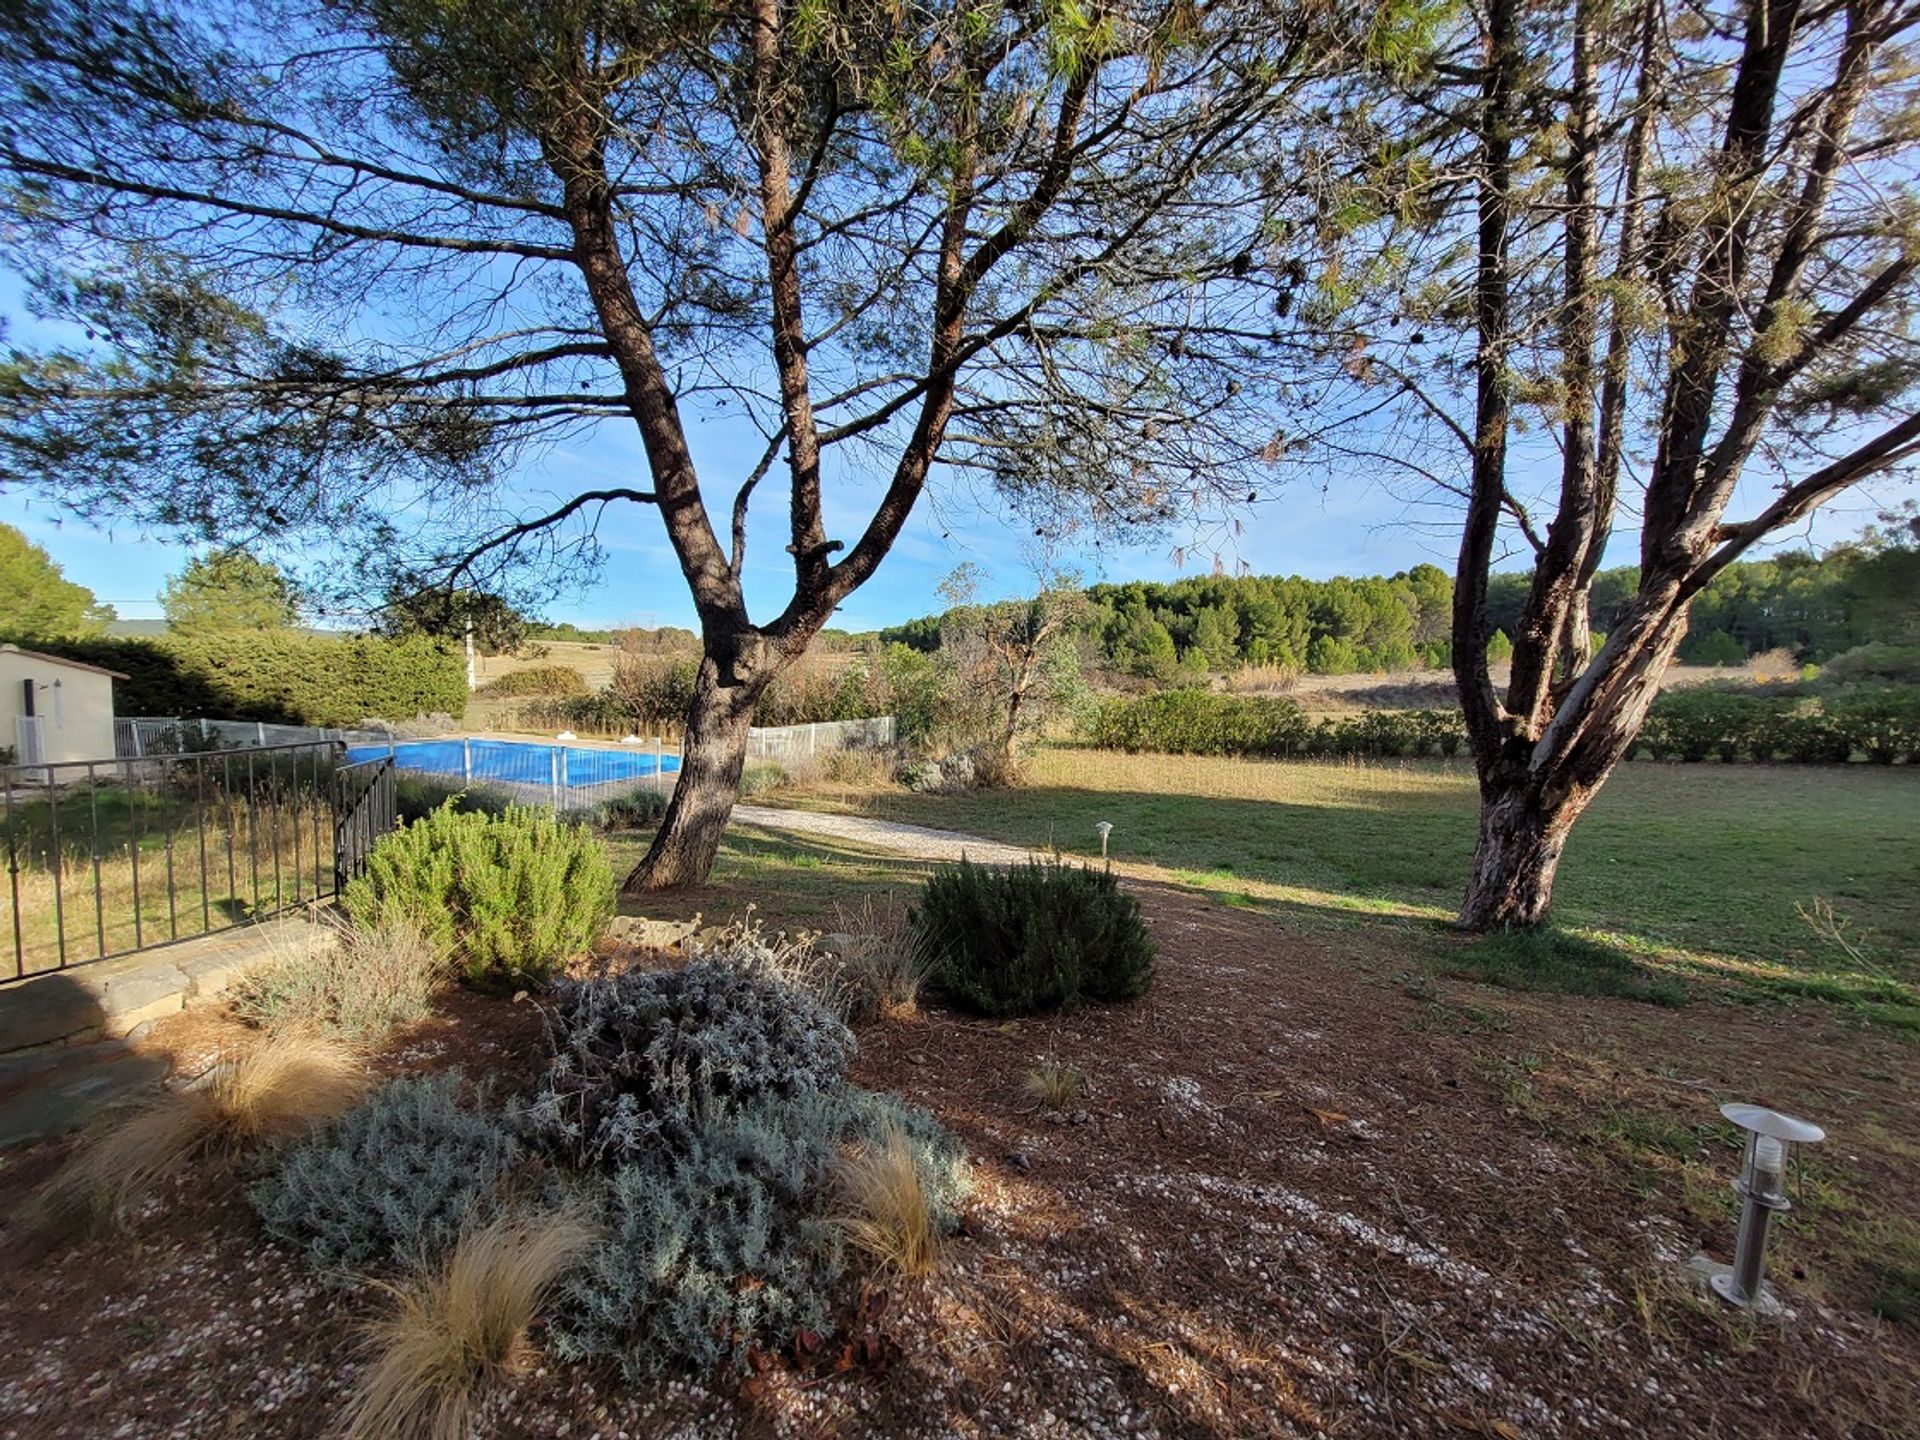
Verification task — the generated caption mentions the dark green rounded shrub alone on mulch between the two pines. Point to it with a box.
[914,860,1154,1016]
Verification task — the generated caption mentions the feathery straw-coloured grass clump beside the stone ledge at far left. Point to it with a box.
[31,1031,367,1231]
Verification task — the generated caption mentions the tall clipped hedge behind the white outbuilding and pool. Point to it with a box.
[19,630,467,726]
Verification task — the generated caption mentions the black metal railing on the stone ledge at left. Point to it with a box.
[0,741,351,983]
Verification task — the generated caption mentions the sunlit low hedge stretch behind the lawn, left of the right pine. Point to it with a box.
[1085,689,1467,756]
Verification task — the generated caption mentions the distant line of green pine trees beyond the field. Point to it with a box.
[879,518,1920,682]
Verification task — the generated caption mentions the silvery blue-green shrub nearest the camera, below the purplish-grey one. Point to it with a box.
[553,1085,970,1379]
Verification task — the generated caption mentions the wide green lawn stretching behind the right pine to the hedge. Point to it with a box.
[768,749,1920,1023]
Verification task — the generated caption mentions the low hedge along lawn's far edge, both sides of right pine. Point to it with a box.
[1081,685,1920,764]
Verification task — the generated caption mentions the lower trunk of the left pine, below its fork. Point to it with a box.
[622,657,766,895]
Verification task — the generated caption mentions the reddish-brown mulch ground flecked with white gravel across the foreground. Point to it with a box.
[0,887,1920,1440]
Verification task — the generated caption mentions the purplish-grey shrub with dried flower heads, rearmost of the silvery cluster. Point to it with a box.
[526,947,854,1165]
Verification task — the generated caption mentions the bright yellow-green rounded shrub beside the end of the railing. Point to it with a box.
[342,803,612,989]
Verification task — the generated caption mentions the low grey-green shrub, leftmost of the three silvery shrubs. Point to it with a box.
[250,1071,520,1271]
